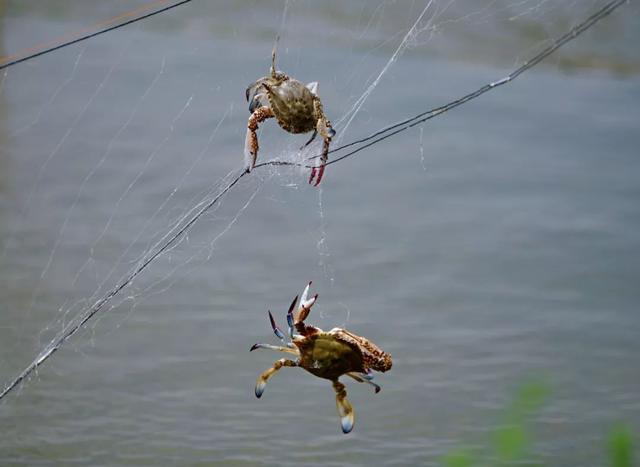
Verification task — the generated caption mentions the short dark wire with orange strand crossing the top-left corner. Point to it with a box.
[0,0,191,70]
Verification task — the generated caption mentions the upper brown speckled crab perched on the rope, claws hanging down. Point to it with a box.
[244,40,336,186]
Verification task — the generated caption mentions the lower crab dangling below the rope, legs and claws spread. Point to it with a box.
[250,282,392,433]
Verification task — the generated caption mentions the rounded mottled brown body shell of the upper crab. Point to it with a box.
[267,79,317,133]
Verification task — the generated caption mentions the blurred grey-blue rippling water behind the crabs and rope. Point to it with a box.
[0,0,640,466]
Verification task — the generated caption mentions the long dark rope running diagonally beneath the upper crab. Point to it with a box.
[0,0,628,401]
